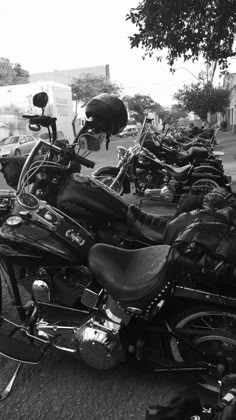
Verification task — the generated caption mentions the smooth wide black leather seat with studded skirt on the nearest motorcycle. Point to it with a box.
[88,244,170,307]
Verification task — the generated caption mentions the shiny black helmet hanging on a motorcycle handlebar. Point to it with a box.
[85,93,128,134]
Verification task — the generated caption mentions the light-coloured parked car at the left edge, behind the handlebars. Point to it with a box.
[0,134,37,157]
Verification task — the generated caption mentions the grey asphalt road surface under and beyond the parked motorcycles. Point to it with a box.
[0,130,236,420]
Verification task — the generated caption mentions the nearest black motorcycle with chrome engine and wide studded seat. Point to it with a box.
[0,143,236,397]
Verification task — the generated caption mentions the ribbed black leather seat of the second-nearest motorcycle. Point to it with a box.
[126,204,170,245]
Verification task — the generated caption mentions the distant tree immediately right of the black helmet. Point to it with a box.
[122,93,163,122]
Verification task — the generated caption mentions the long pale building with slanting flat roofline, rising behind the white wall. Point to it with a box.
[30,64,110,85]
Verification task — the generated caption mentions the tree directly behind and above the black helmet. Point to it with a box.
[71,73,122,104]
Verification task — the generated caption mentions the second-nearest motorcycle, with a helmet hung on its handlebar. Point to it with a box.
[0,93,171,249]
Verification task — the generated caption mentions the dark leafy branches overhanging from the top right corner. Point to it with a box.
[126,0,236,71]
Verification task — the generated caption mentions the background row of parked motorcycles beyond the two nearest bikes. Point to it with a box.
[93,114,231,203]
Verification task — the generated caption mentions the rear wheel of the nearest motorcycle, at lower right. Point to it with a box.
[169,305,236,392]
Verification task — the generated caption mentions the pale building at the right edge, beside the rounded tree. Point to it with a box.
[223,73,236,133]
